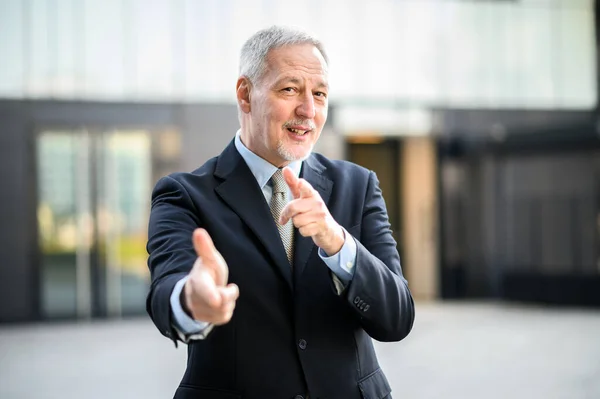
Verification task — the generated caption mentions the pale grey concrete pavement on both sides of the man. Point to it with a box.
[0,303,600,399]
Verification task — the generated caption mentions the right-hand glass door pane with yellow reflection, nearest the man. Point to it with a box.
[97,131,151,315]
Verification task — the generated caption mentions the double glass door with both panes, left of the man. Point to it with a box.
[37,129,152,319]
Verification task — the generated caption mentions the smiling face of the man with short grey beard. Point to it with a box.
[242,44,328,167]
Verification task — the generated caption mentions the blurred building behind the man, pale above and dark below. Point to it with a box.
[0,0,600,322]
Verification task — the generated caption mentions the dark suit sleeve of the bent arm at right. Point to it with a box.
[346,172,415,341]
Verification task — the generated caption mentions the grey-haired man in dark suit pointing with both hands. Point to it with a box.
[147,27,414,399]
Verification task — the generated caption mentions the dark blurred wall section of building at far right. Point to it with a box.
[441,141,600,306]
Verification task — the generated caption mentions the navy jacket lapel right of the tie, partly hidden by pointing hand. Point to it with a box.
[294,155,333,281]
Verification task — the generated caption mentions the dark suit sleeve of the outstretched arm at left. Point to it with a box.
[146,176,199,341]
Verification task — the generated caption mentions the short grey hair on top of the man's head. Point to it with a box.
[240,26,329,84]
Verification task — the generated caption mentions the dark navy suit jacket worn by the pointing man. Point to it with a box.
[147,142,414,399]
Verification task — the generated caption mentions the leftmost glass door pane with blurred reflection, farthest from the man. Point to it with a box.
[37,132,93,317]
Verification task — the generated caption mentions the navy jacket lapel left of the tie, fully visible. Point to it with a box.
[215,141,293,289]
